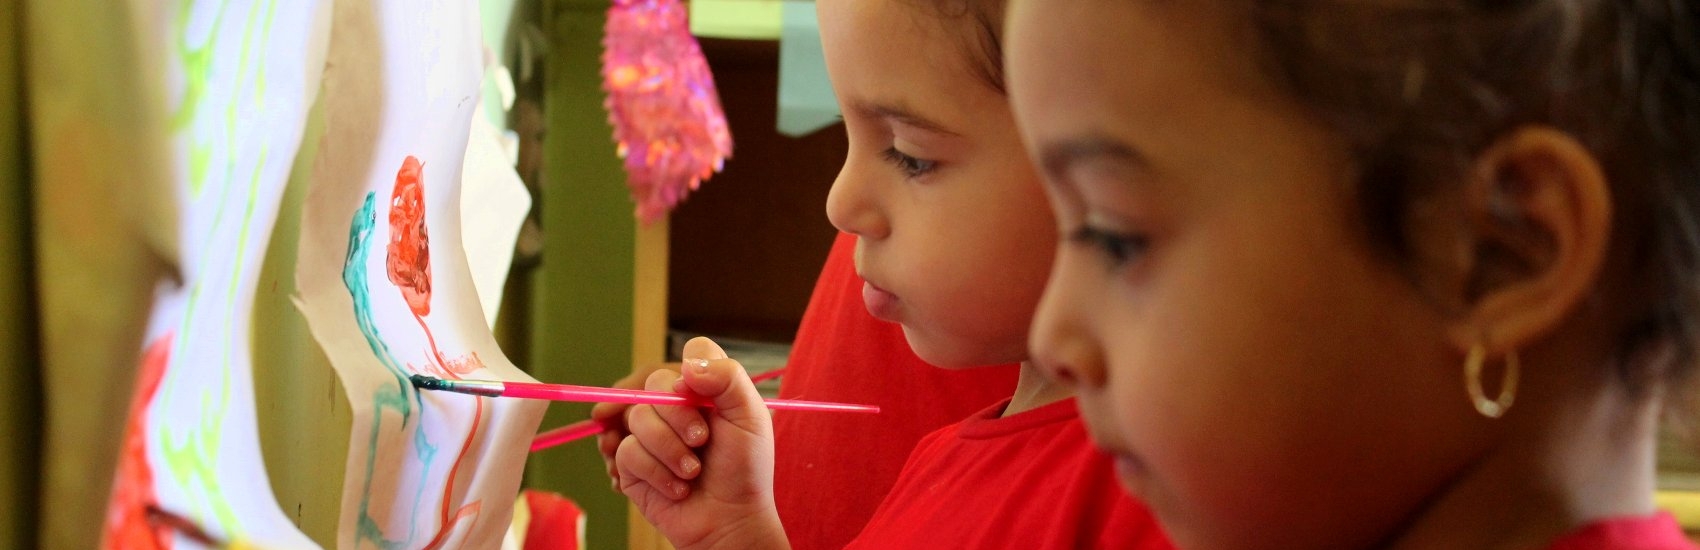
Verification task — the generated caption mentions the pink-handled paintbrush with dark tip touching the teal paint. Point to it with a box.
[411,375,879,413]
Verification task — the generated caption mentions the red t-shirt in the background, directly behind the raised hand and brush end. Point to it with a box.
[774,234,1017,550]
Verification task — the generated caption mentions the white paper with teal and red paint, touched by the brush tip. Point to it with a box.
[296,0,544,548]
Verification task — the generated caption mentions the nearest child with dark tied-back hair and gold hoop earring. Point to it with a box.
[1008,0,1700,548]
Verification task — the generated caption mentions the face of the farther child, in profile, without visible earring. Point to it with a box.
[818,0,1056,367]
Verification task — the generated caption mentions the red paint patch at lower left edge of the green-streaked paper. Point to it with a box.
[102,333,172,550]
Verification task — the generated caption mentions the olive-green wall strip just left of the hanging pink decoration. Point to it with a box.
[527,0,636,548]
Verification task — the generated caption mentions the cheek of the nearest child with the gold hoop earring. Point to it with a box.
[1100,227,1455,548]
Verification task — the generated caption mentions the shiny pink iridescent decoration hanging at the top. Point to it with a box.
[602,0,733,222]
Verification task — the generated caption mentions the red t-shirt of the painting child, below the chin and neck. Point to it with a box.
[847,399,1173,550]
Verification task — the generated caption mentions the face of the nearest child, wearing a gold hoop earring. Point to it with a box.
[1006,0,1486,548]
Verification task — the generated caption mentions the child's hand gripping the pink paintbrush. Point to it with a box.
[614,338,787,548]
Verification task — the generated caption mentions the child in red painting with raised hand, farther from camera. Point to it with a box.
[615,0,1166,548]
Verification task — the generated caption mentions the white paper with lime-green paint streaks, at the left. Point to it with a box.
[107,0,330,548]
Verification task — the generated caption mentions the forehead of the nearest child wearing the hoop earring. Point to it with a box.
[1005,0,1282,148]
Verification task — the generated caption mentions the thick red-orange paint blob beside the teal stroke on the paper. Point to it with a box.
[388,154,430,316]
